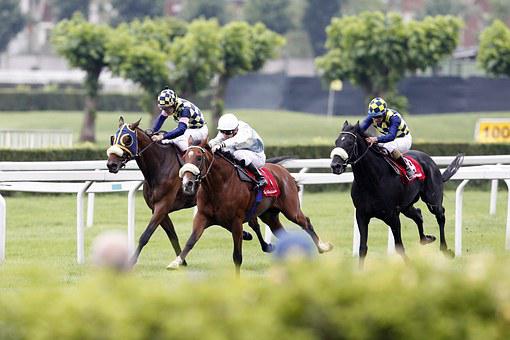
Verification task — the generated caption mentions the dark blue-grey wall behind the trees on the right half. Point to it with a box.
[225,74,510,115]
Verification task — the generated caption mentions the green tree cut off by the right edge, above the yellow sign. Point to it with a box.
[477,20,510,77]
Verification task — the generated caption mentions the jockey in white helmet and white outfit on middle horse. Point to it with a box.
[209,113,267,188]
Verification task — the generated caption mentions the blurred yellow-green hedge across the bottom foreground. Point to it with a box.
[0,255,510,340]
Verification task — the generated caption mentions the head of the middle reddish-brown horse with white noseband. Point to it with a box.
[179,138,214,195]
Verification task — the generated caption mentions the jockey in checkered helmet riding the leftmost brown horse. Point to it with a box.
[149,89,209,151]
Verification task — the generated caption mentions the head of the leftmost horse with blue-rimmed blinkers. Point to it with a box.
[106,116,140,173]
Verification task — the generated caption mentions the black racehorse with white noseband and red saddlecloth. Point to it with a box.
[331,121,464,265]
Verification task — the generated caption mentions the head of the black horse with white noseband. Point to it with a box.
[330,121,365,175]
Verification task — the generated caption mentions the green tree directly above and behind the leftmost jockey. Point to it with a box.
[106,18,184,114]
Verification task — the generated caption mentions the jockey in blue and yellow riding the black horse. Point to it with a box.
[360,98,414,178]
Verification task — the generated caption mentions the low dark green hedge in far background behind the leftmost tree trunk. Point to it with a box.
[0,90,141,111]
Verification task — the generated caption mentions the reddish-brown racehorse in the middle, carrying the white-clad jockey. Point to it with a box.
[167,145,332,274]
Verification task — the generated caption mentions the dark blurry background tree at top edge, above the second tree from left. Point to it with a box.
[112,0,165,24]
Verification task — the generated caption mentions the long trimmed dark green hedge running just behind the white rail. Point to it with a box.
[0,143,510,162]
